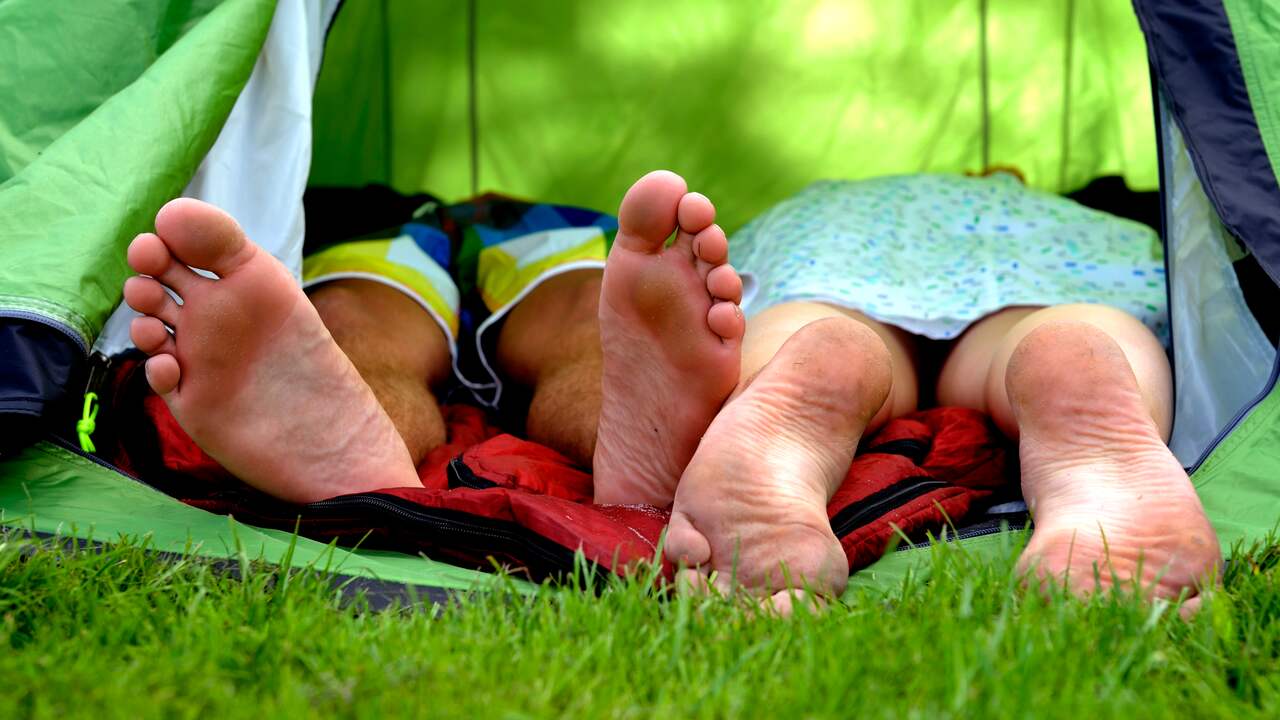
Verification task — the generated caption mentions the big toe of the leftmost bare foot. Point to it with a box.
[148,197,253,274]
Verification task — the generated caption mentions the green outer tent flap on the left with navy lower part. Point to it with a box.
[0,0,274,427]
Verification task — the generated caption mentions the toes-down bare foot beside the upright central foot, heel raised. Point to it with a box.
[666,318,892,602]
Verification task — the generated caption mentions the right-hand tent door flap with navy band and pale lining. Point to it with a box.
[1134,0,1280,476]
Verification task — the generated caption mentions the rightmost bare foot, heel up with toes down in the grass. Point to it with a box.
[1005,323,1221,607]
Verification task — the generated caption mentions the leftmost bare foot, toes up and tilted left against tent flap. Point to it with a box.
[124,199,421,502]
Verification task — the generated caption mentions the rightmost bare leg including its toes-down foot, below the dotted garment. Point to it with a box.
[938,305,1221,597]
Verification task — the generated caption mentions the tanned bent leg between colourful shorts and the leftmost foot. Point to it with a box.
[310,279,452,465]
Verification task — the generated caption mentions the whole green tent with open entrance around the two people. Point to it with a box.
[0,0,1280,588]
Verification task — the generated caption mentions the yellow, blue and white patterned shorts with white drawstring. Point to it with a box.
[302,191,618,406]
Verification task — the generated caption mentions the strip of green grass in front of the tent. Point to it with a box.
[0,537,1280,720]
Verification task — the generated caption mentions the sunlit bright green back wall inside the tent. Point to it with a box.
[311,0,1156,232]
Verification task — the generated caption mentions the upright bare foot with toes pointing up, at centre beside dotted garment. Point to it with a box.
[591,170,746,506]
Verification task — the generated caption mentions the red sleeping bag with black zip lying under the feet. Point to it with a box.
[100,361,1009,579]
